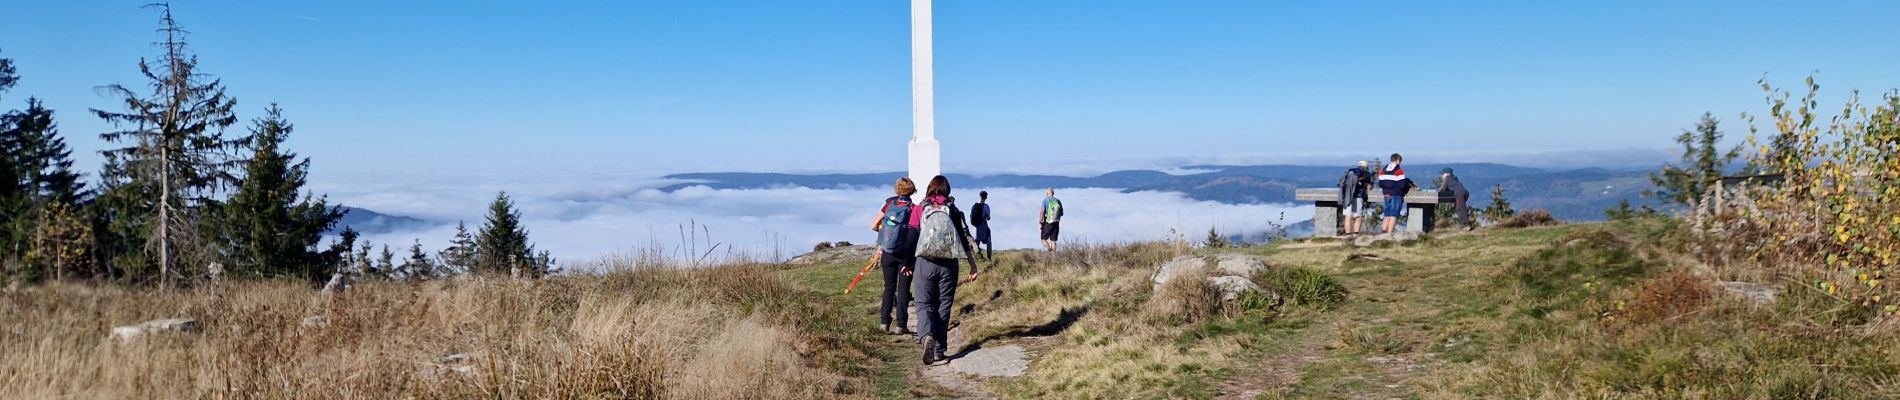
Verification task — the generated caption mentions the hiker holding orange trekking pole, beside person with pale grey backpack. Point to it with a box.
[870,178,918,336]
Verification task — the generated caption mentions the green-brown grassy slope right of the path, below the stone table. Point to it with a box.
[789,222,1900,398]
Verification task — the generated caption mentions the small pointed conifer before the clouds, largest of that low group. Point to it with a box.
[473,191,553,277]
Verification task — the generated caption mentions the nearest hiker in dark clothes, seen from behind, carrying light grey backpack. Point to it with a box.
[912,174,977,366]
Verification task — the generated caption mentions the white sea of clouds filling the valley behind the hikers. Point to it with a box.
[310,173,1313,271]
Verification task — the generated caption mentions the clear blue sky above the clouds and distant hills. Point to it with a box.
[0,0,1900,176]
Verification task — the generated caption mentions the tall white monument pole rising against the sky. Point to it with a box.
[910,0,942,188]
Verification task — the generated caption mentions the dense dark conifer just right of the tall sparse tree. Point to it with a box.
[220,104,346,282]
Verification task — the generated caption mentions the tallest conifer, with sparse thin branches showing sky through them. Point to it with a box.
[93,4,249,288]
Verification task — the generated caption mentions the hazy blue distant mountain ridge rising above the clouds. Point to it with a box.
[661,163,1651,220]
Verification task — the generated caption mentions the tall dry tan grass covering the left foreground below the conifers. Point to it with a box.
[0,265,868,398]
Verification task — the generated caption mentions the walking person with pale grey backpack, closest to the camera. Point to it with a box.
[910,174,977,366]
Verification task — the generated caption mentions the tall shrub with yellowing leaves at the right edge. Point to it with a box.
[1725,78,1900,315]
